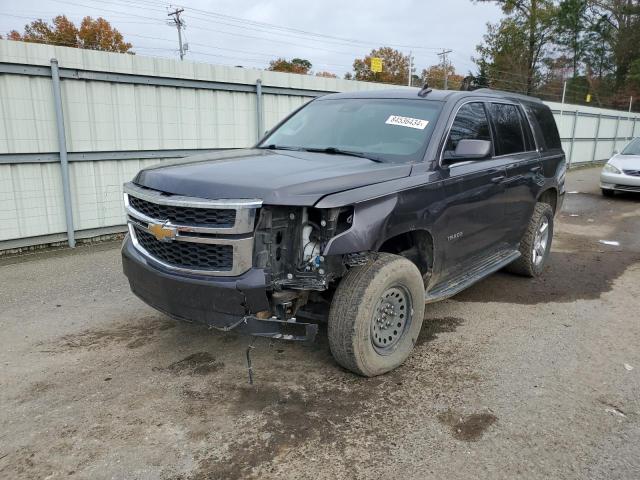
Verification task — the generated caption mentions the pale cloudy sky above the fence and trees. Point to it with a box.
[0,0,501,77]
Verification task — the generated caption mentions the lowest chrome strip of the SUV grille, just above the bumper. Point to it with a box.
[128,222,253,277]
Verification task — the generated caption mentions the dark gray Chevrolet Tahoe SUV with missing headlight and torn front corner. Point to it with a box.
[122,87,566,376]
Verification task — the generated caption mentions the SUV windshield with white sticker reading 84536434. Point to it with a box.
[259,98,442,162]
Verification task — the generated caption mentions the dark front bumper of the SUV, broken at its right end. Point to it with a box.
[122,236,317,341]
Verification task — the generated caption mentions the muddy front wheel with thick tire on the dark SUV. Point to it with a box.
[328,253,425,377]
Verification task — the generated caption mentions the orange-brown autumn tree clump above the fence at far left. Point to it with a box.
[8,15,132,53]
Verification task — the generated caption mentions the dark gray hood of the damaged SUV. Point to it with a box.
[134,149,411,206]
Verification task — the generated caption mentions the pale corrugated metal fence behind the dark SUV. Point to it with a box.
[0,40,640,250]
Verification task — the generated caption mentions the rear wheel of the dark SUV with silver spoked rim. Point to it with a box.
[506,203,553,277]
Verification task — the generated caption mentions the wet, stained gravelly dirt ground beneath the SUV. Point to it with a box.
[0,169,640,480]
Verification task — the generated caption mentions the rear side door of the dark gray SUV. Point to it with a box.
[487,101,544,247]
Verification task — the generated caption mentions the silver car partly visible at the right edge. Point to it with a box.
[600,137,640,197]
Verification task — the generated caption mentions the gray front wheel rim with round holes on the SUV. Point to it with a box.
[371,286,412,355]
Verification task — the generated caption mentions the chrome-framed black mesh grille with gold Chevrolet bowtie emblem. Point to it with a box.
[124,183,262,276]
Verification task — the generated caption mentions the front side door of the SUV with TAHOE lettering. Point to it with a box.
[435,101,506,281]
